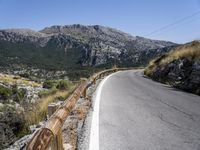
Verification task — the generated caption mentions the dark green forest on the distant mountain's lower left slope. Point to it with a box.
[0,40,82,70]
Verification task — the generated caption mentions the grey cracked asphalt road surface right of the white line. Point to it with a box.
[99,70,200,150]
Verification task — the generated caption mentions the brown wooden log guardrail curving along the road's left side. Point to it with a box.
[26,68,127,150]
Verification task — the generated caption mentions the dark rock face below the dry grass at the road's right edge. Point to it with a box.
[152,58,200,95]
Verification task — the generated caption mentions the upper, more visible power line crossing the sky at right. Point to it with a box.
[146,10,200,36]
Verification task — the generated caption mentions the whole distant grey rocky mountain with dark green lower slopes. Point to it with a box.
[0,24,176,78]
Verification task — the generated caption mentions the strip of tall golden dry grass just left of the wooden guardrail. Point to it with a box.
[25,85,76,125]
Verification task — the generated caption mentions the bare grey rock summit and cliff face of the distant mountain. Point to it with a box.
[40,25,176,65]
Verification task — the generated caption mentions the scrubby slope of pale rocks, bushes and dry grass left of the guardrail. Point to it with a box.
[0,74,77,149]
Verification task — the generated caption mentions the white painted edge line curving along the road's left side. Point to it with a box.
[89,73,118,150]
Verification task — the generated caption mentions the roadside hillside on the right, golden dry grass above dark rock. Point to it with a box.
[145,41,200,95]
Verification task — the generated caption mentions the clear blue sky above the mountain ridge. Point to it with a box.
[0,0,200,43]
